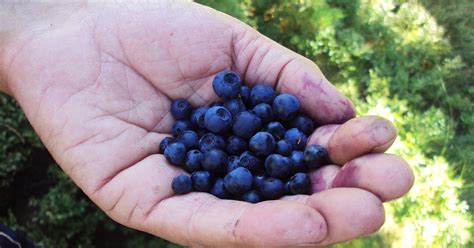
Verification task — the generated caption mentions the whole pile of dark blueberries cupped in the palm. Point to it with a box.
[160,70,328,203]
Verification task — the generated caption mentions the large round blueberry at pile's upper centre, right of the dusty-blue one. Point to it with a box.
[232,111,262,139]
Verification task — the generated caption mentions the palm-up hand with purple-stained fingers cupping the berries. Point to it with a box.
[0,1,414,247]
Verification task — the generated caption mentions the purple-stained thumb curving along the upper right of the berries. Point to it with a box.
[233,23,355,124]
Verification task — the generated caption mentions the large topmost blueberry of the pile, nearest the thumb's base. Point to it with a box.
[212,70,241,99]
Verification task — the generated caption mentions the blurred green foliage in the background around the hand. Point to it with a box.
[0,0,474,247]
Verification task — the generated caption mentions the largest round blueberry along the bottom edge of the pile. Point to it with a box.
[224,167,252,195]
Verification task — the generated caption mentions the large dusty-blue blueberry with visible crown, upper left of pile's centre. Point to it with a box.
[204,106,232,133]
